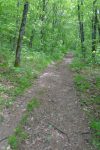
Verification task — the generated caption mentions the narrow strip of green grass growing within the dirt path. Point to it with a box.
[8,98,40,150]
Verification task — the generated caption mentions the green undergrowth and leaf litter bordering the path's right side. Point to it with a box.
[71,55,100,149]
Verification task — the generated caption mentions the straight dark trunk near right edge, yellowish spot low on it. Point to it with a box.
[92,0,98,62]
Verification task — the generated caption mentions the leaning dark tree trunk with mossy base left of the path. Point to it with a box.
[14,1,29,67]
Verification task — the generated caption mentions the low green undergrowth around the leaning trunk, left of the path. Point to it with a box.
[0,50,63,112]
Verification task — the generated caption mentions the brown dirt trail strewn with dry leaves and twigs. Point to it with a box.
[0,54,94,150]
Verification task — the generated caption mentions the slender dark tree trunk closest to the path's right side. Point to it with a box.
[78,0,86,58]
